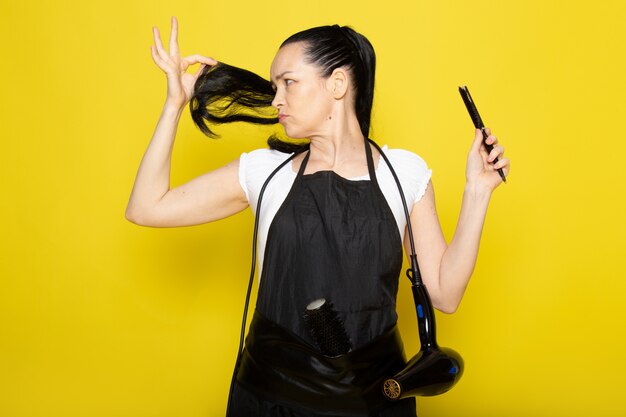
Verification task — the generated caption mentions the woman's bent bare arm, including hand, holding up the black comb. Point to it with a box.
[405,130,510,313]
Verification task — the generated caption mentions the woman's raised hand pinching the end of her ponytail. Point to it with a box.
[150,16,217,108]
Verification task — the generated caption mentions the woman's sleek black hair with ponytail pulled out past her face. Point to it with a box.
[189,25,376,153]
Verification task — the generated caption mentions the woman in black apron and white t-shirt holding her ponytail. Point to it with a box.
[126,18,510,417]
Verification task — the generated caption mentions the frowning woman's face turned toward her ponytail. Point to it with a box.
[270,42,334,138]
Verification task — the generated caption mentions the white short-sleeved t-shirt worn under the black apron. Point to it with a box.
[239,145,432,276]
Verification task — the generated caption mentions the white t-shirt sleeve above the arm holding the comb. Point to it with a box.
[390,149,432,204]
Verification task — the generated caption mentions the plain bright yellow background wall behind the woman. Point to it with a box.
[0,0,626,417]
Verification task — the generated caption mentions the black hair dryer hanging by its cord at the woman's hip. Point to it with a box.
[383,255,464,401]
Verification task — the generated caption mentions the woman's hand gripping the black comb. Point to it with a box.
[465,128,511,191]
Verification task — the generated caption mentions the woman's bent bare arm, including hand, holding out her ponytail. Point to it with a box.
[126,18,248,227]
